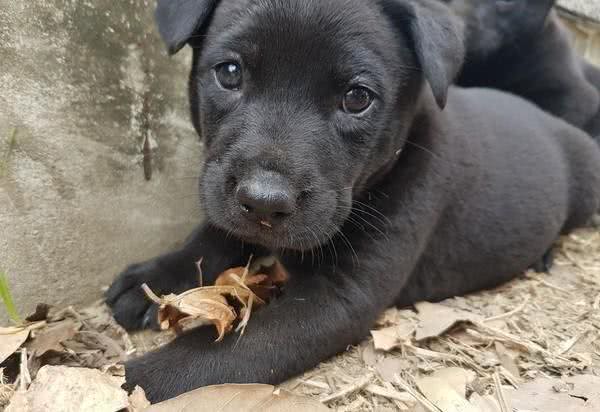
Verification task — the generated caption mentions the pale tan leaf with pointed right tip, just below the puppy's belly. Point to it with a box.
[415,302,483,341]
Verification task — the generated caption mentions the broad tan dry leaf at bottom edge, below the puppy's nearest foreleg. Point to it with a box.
[145,385,329,412]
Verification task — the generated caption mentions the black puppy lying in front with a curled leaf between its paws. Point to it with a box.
[107,0,600,401]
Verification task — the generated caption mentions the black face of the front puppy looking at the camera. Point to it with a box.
[157,0,460,250]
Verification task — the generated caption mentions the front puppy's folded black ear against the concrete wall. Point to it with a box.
[155,0,218,54]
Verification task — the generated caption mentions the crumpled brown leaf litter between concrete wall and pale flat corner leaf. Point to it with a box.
[0,302,134,411]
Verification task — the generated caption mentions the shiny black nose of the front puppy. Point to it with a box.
[236,172,295,226]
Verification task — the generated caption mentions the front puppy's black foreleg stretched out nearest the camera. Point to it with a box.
[126,255,410,402]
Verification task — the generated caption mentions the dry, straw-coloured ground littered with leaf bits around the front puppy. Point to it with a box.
[0,228,600,412]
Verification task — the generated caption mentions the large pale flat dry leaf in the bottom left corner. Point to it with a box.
[6,366,129,412]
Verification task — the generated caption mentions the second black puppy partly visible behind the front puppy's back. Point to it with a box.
[450,0,600,139]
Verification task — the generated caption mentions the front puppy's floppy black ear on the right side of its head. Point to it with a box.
[382,0,465,109]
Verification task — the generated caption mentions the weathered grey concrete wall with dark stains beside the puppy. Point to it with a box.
[0,0,201,324]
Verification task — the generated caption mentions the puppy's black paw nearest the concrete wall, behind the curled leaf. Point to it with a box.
[106,259,193,330]
